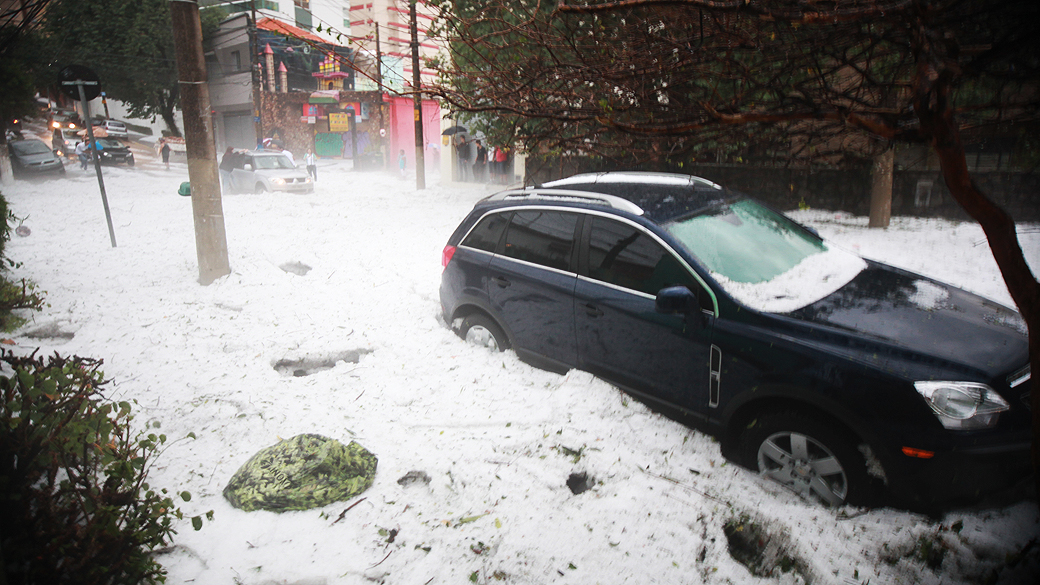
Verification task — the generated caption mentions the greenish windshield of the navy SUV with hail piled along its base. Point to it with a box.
[665,200,866,312]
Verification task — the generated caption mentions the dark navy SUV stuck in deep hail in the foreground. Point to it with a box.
[440,173,1031,509]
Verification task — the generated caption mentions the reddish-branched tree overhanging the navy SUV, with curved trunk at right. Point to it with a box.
[433,0,1040,495]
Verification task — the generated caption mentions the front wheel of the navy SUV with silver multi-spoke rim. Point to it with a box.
[740,411,872,506]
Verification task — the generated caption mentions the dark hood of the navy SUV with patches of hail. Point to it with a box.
[787,261,1029,375]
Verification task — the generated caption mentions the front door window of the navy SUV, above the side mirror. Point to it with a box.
[589,218,710,308]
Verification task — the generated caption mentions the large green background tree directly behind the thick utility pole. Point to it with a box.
[46,0,226,136]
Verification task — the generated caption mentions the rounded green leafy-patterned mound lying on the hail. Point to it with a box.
[224,434,376,512]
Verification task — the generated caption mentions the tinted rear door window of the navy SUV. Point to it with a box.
[502,209,578,271]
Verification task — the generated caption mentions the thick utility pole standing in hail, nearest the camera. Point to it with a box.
[170,0,231,285]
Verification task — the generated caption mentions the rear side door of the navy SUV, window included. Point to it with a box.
[488,208,579,367]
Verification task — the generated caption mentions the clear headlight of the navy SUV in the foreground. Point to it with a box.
[913,382,1011,431]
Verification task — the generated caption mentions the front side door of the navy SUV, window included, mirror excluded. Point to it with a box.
[574,214,718,414]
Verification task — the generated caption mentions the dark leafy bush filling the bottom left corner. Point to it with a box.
[0,352,201,585]
